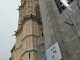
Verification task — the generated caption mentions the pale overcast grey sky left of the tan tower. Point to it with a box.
[0,0,20,60]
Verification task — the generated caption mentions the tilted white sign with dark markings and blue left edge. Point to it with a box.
[44,42,62,60]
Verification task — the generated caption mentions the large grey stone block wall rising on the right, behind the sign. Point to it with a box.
[39,0,80,60]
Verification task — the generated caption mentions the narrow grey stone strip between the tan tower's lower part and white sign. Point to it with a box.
[37,37,45,60]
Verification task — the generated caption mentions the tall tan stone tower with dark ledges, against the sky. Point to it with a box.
[10,0,42,60]
